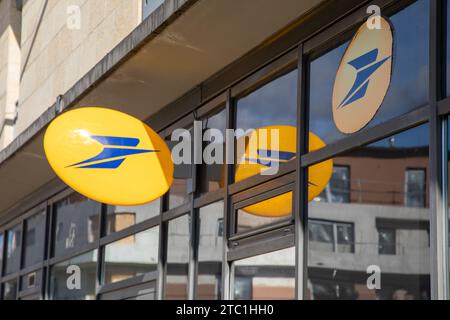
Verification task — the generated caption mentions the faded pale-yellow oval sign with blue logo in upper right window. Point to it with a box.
[333,18,393,134]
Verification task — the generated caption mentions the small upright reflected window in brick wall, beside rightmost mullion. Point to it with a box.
[405,169,426,208]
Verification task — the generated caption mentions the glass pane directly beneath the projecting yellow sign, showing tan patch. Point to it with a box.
[107,199,161,234]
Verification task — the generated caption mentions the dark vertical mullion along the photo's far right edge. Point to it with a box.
[429,0,448,299]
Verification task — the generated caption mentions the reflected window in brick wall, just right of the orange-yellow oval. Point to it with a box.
[314,165,350,203]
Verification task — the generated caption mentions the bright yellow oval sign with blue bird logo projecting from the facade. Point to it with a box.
[44,107,174,205]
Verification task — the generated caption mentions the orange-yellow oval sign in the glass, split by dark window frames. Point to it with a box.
[235,126,333,217]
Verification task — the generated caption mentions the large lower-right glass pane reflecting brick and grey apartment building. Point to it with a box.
[308,124,430,300]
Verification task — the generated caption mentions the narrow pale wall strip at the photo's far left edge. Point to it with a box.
[0,0,21,149]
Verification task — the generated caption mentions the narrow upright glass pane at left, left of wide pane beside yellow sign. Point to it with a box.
[24,211,46,267]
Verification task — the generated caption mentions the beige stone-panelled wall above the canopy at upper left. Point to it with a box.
[15,0,142,136]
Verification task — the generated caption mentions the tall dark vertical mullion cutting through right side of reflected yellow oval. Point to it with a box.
[294,45,309,300]
